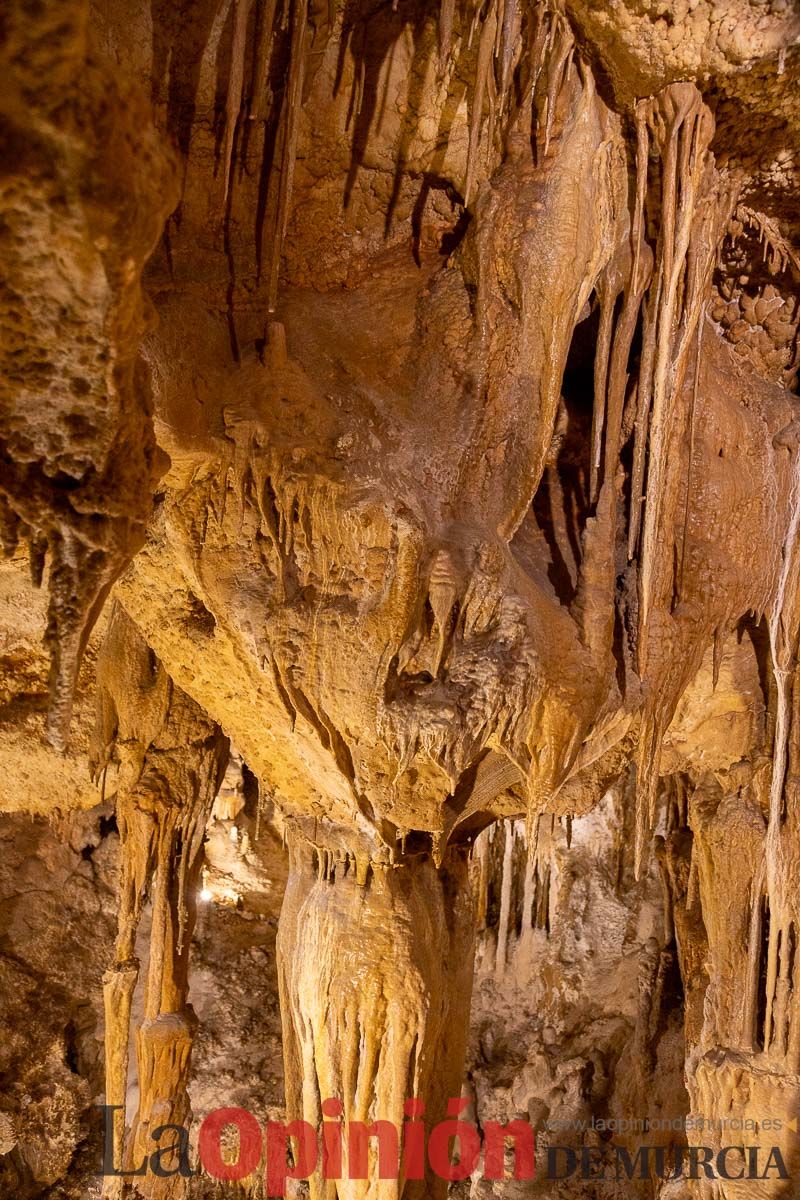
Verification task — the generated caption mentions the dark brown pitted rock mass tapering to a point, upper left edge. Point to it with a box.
[0,6,179,751]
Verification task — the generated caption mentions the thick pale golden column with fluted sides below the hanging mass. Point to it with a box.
[278,838,474,1200]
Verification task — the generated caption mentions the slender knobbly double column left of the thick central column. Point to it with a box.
[95,608,228,1200]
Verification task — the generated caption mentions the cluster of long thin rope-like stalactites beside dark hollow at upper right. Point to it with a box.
[578,83,736,874]
